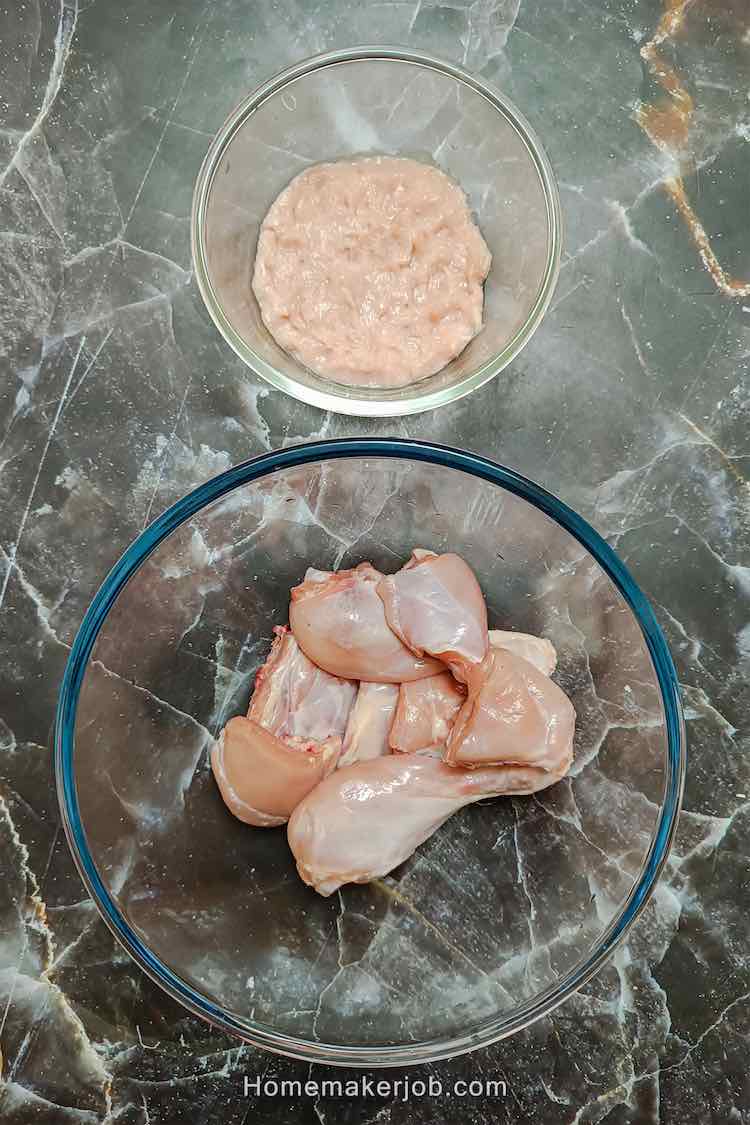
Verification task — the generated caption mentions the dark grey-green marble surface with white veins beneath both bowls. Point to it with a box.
[0,0,750,1125]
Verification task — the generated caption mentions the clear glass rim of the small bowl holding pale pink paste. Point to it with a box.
[190,45,562,417]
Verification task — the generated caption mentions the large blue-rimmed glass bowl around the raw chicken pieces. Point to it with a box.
[55,440,685,1067]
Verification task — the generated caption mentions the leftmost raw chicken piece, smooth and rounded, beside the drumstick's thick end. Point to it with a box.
[211,716,341,828]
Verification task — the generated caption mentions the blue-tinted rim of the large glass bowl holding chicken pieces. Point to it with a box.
[54,438,686,1068]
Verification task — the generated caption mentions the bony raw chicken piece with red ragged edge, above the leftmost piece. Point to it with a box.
[247,626,356,743]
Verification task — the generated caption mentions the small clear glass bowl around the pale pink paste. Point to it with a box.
[191,47,561,417]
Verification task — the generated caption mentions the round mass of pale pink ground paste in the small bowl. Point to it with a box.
[252,155,490,387]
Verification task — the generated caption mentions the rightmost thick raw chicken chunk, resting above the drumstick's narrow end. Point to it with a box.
[445,648,576,775]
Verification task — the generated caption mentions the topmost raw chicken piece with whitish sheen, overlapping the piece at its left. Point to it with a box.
[378,549,488,683]
